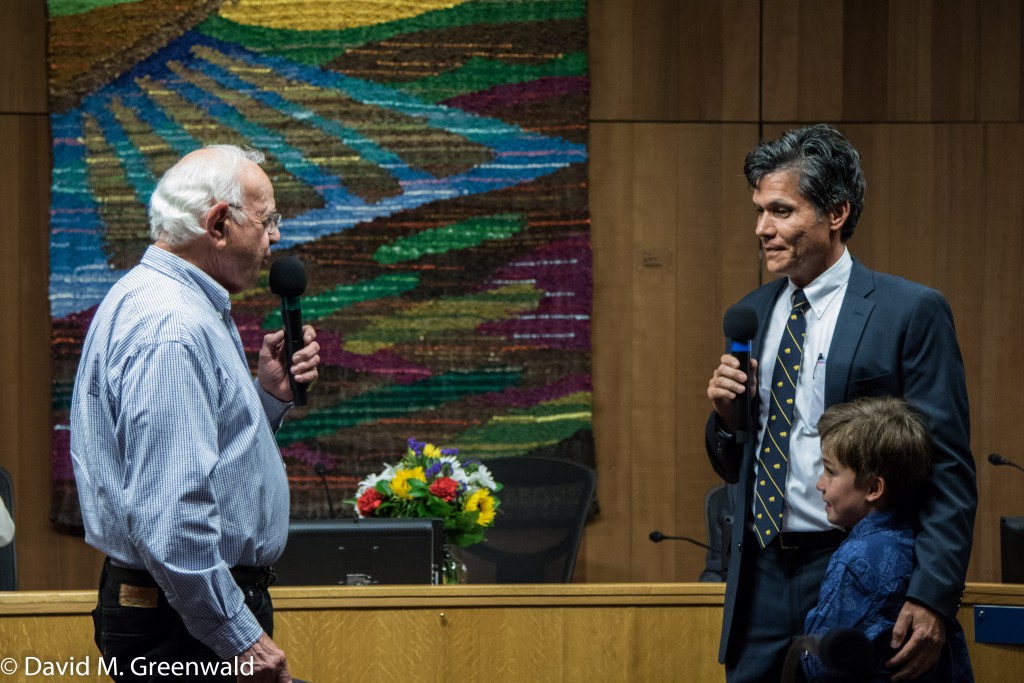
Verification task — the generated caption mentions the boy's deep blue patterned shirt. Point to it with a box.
[802,510,974,683]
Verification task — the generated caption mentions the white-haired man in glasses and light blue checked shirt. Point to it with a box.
[71,145,319,681]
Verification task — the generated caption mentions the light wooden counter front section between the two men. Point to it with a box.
[274,584,724,682]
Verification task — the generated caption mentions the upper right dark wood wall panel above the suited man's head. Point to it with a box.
[763,0,1022,123]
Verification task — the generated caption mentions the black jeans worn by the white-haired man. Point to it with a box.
[92,567,273,683]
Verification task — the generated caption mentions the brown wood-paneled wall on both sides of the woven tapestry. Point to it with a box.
[0,0,1024,589]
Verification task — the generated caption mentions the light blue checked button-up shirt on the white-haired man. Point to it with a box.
[71,247,291,657]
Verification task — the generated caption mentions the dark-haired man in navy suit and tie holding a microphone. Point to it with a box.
[706,124,978,683]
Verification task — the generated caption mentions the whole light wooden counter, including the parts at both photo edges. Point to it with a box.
[0,584,1024,683]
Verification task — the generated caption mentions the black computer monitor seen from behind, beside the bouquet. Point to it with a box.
[273,518,444,586]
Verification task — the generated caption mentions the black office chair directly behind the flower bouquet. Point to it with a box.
[458,456,597,584]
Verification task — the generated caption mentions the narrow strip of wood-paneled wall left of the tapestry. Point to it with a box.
[0,0,108,589]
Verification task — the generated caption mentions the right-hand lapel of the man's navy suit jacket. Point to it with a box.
[825,259,874,408]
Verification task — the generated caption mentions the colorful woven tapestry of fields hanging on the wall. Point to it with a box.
[48,0,594,530]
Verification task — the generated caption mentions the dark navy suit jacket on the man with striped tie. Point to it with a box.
[706,260,978,661]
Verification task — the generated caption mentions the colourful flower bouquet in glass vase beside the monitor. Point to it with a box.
[348,439,502,584]
